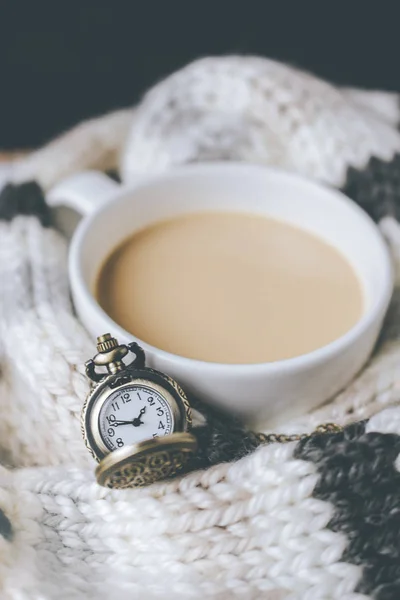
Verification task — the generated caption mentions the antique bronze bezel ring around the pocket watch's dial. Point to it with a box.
[81,368,191,462]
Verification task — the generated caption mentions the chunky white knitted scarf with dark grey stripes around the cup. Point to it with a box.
[0,56,400,600]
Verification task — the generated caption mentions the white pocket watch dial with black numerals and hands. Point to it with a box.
[99,384,174,450]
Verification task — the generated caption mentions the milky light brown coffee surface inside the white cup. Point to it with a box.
[95,212,363,364]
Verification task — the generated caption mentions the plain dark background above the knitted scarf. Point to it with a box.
[0,0,400,149]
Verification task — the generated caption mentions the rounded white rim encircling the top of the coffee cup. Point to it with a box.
[68,161,394,375]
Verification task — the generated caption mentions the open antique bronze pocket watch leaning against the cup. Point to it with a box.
[81,333,197,488]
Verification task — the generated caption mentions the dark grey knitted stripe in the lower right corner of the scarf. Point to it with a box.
[294,422,400,600]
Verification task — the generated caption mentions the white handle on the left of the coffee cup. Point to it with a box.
[47,171,120,217]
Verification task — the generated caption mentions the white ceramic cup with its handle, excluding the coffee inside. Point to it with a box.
[48,163,393,427]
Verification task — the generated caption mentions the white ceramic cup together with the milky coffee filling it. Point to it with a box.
[48,163,393,427]
